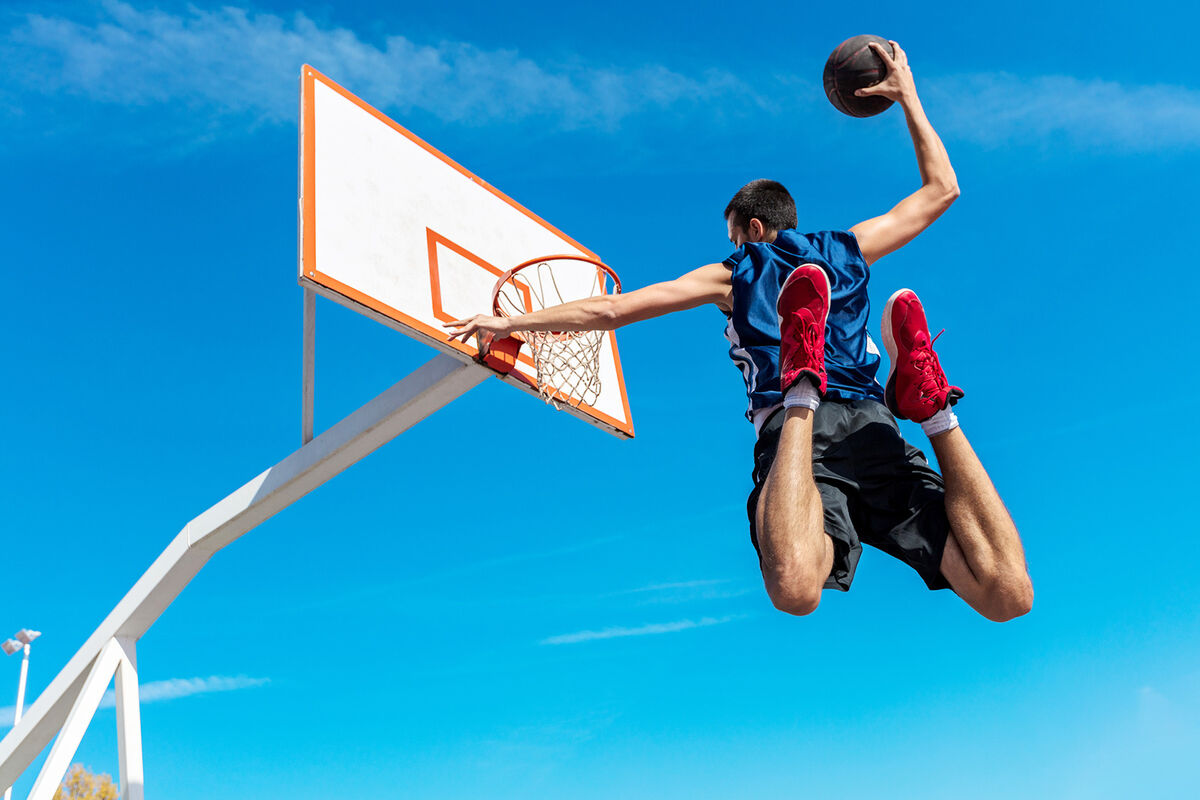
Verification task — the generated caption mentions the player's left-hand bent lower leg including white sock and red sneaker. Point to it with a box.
[755,264,833,614]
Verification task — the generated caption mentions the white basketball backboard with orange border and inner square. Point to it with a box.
[299,65,634,437]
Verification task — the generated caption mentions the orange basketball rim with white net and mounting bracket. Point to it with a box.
[487,255,620,408]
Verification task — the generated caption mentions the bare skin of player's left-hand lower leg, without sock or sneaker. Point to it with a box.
[756,407,833,614]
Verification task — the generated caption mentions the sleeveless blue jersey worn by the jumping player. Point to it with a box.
[725,230,883,425]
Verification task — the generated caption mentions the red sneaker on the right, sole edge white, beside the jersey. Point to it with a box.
[883,289,964,422]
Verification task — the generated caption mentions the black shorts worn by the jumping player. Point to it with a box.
[746,399,950,591]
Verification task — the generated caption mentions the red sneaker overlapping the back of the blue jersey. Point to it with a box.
[775,264,829,396]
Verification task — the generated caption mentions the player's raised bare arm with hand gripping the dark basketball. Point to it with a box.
[850,42,959,264]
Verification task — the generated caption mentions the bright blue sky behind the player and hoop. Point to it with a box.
[0,0,1200,800]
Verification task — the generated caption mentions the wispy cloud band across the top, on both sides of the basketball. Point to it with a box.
[0,0,1200,152]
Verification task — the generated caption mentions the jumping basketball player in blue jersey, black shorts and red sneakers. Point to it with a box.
[446,42,1033,621]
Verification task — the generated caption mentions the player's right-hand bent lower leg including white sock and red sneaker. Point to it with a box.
[883,289,1033,621]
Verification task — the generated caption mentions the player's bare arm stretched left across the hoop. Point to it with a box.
[443,264,732,341]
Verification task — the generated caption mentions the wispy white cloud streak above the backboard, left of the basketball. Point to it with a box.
[5,1,748,127]
